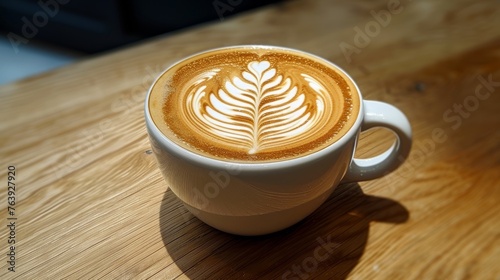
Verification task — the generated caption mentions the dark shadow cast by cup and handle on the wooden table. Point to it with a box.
[160,183,409,279]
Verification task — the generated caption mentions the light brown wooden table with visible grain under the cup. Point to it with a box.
[0,0,500,279]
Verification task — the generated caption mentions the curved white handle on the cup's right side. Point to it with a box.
[341,100,412,183]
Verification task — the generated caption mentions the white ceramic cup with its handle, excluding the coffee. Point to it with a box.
[145,46,412,235]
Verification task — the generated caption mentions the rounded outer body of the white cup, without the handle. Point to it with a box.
[147,110,357,235]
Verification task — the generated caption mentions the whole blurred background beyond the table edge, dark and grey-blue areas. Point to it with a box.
[0,0,280,84]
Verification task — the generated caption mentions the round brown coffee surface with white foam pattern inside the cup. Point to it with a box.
[149,46,360,162]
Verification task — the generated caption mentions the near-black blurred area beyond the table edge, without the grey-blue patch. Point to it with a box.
[0,0,279,53]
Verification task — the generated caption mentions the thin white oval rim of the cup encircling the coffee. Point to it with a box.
[144,44,364,172]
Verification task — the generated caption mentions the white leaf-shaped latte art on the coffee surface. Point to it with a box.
[185,61,327,154]
